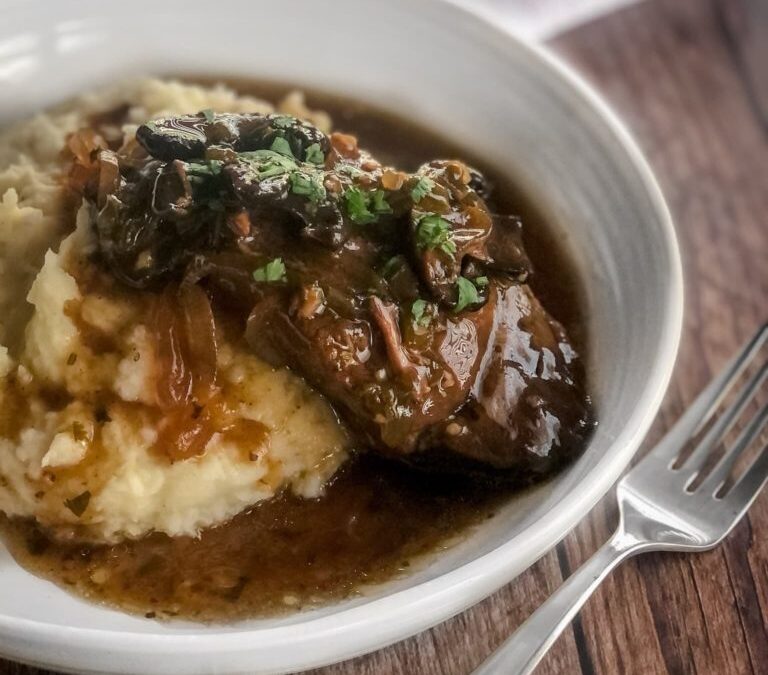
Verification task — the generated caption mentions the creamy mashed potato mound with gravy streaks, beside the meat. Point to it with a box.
[0,79,348,542]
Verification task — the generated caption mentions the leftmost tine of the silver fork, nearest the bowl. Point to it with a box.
[647,323,768,462]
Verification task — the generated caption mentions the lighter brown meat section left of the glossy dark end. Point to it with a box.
[246,278,493,456]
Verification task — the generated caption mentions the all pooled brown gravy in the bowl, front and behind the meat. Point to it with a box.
[0,82,586,621]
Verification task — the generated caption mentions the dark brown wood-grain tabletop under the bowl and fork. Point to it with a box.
[0,0,768,675]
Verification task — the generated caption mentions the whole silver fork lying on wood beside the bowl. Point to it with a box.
[474,324,768,675]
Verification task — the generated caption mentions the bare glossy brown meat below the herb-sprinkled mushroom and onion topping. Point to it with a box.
[247,274,591,478]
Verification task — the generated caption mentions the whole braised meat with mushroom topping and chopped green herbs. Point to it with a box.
[79,111,592,480]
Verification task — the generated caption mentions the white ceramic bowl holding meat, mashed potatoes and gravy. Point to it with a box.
[0,0,682,674]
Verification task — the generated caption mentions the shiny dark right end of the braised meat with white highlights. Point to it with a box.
[412,285,592,477]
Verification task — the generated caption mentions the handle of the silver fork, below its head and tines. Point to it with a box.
[474,531,652,675]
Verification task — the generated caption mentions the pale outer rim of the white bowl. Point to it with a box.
[0,0,683,673]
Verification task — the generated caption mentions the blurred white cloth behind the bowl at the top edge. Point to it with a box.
[452,0,639,40]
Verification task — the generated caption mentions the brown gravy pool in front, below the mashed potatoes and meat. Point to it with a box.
[4,457,501,621]
